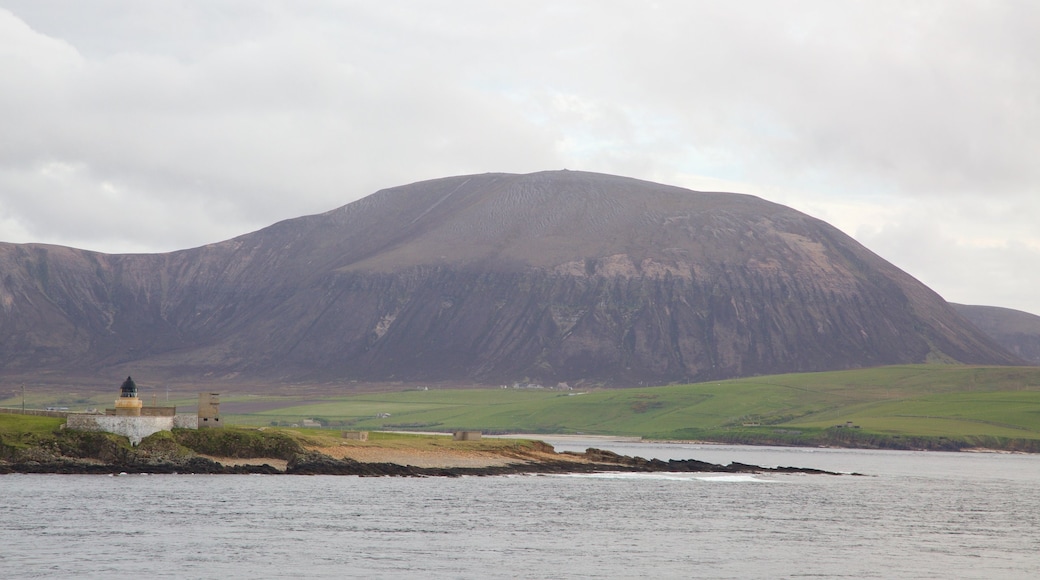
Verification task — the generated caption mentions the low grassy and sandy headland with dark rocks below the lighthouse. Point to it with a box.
[0,429,844,477]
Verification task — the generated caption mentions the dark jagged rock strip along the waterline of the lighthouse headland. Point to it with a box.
[0,448,839,477]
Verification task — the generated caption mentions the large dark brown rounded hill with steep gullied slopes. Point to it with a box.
[0,172,1018,385]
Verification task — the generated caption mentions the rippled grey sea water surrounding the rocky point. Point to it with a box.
[0,437,1040,579]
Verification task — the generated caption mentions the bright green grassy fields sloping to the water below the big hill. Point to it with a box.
[226,365,1040,450]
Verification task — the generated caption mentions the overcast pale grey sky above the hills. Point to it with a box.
[0,0,1040,314]
